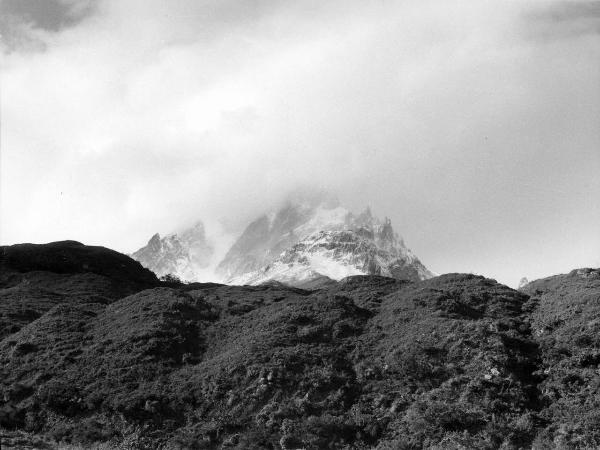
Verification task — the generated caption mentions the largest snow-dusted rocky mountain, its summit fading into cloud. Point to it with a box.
[217,197,433,285]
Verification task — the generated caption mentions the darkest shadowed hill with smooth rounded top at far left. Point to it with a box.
[0,241,159,339]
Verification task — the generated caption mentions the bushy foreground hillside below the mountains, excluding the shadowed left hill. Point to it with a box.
[0,241,600,449]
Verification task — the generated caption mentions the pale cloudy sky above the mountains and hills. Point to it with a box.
[0,0,600,286]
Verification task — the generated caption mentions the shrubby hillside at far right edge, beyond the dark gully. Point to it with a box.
[523,269,600,448]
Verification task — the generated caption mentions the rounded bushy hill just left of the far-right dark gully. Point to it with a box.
[355,274,539,449]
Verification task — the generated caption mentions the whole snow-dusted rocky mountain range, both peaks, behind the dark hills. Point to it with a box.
[131,195,433,286]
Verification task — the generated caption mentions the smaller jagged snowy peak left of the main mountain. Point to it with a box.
[131,222,213,281]
